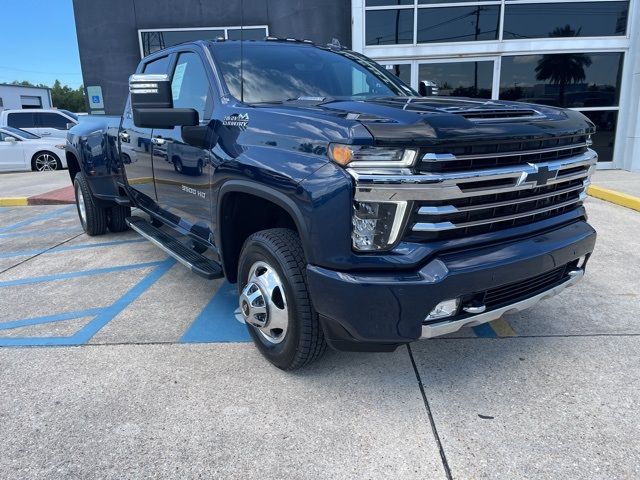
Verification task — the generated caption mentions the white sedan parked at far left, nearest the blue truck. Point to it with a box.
[0,127,67,172]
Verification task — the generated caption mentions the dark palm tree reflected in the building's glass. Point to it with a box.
[536,25,591,106]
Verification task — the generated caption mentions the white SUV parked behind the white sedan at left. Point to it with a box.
[0,108,79,138]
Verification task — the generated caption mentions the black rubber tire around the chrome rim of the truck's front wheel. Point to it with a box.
[238,228,327,370]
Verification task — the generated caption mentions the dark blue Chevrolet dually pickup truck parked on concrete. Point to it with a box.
[66,39,597,369]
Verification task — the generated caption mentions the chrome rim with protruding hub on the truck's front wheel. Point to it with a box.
[240,262,289,343]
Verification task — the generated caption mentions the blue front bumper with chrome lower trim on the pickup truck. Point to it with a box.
[307,221,596,350]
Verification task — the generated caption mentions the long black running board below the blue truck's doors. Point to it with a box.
[126,217,224,280]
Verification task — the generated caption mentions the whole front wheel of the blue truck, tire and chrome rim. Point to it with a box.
[238,228,327,370]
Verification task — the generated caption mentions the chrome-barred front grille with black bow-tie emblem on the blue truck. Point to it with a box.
[349,145,598,241]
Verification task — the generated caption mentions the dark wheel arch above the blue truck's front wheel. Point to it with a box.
[215,180,312,283]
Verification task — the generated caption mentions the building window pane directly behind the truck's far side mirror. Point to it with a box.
[418,61,493,98]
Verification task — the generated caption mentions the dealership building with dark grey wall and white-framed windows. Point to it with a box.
[73,0,640,170]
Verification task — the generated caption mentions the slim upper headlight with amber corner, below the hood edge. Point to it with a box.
[329,143,418,168]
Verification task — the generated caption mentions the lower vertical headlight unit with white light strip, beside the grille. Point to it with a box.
[351,202,407,251]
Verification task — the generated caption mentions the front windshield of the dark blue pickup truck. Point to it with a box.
[212,42,416,103]
